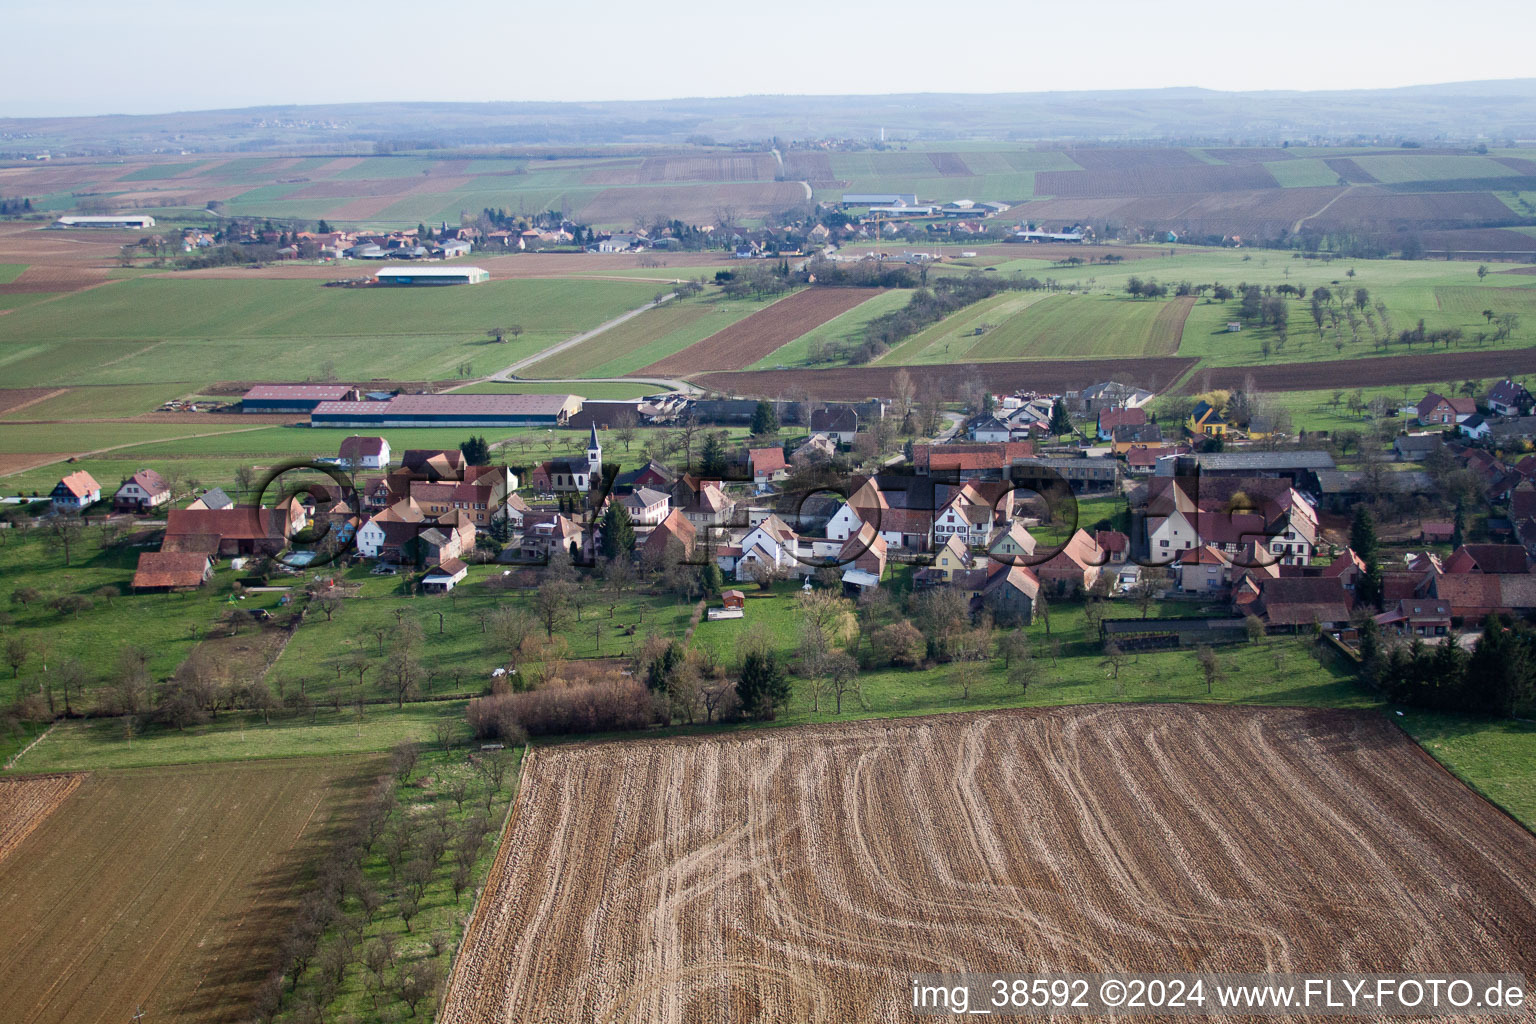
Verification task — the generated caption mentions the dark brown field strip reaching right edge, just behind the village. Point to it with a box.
[1184,348,1536,395]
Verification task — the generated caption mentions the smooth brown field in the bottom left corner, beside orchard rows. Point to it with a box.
[0,758,379,1024]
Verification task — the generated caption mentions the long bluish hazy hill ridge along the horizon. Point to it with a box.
[0,78,1536,157]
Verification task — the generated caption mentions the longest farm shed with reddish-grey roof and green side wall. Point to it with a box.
[309,395,582,428]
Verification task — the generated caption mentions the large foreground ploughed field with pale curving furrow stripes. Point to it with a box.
[438,705,1536,1024]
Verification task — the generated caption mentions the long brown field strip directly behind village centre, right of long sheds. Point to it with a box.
[691,356,1191,402]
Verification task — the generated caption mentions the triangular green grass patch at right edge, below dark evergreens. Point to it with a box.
[1392,708,1536,831]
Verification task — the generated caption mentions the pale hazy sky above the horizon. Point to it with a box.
[0,0,1536,117]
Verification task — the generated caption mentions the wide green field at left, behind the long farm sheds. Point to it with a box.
[0,278,654,390]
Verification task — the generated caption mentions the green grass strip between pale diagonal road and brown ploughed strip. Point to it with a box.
[522,296,771,378]
